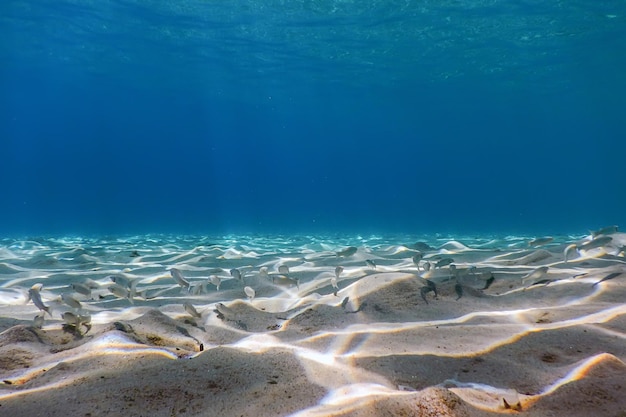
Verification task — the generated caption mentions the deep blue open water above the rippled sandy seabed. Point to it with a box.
[0,0,626,235]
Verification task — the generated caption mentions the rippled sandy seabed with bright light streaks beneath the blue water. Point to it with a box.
[0,228,626,417]
